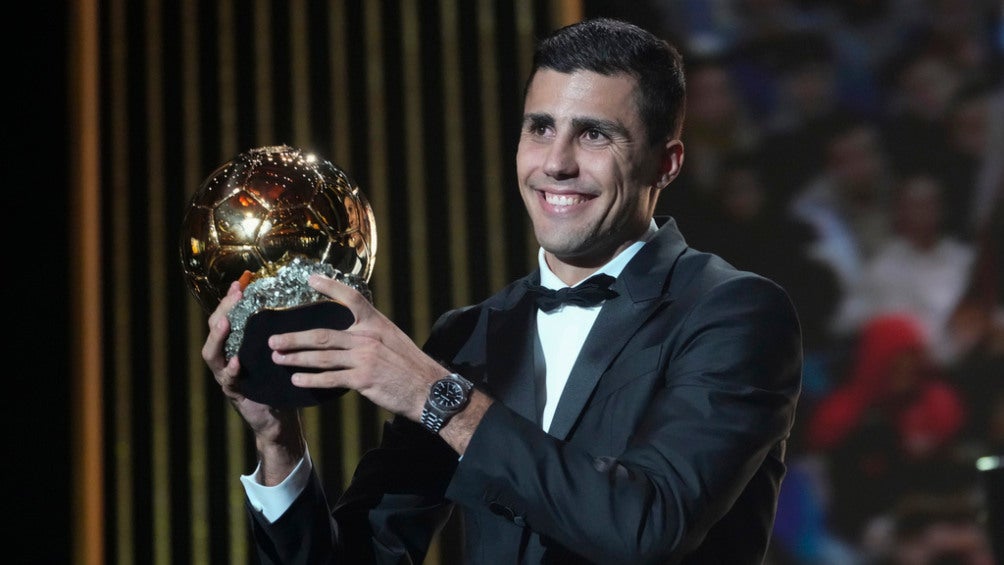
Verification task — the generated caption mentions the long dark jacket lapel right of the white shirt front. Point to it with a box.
[548,220,687,440]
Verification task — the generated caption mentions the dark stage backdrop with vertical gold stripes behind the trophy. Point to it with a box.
[69,0,580,564]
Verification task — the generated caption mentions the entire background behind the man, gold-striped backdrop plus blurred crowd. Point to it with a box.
[25,0,1004,565]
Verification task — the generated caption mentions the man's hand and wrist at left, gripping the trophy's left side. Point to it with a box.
[202,281,305,486]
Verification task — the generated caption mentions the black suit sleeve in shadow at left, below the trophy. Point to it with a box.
[247,312,477,565]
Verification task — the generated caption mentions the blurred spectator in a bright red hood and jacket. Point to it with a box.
[805,314,965,544]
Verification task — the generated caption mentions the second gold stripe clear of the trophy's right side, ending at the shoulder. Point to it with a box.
[440,0,471,306]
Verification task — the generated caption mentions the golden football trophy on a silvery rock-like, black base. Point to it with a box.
[180,146,377,407]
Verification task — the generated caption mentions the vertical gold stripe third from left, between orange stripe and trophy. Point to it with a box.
[143,0,172,565]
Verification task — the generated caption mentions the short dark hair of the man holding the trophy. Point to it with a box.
[523,18,687,144]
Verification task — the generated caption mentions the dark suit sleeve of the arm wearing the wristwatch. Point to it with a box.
[447,276,801,563]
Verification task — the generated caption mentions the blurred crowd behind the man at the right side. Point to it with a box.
[594,0,1004,565]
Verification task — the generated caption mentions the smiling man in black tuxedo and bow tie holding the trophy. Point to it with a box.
[203,19,801,564]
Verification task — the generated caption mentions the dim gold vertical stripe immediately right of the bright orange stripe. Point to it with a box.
[108,0,136,564]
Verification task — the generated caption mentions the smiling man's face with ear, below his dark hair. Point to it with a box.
[516,69,683,276]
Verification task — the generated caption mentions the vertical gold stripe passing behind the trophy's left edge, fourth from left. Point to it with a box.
[180,0,212,565]
